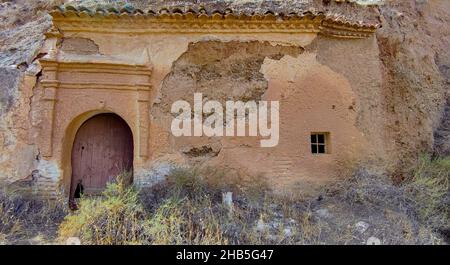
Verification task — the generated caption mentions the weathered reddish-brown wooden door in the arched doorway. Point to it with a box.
[70,114,133,201]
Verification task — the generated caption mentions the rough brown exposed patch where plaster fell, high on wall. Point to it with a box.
[160,41,303,112]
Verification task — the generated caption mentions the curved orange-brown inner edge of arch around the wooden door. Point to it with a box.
[61,110,136,198]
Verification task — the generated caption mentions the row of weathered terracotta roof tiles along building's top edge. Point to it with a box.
[52,0,379,29]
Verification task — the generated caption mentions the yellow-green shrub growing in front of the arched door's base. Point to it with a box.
[59,174,149,245]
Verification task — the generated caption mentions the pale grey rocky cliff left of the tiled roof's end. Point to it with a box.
[0,1,51,115]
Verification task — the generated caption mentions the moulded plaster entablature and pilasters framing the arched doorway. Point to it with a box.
[40,57,152,157]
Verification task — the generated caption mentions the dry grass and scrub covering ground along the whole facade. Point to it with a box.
[0,156,450,245]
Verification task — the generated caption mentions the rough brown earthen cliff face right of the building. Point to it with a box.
[377,0,450,171]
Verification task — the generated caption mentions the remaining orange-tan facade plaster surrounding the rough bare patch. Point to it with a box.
[1,23,383,195]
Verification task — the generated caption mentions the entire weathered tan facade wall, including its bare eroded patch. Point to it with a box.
[1,29,384,196]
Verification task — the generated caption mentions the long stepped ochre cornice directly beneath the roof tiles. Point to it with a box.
[50,7,379,38]
